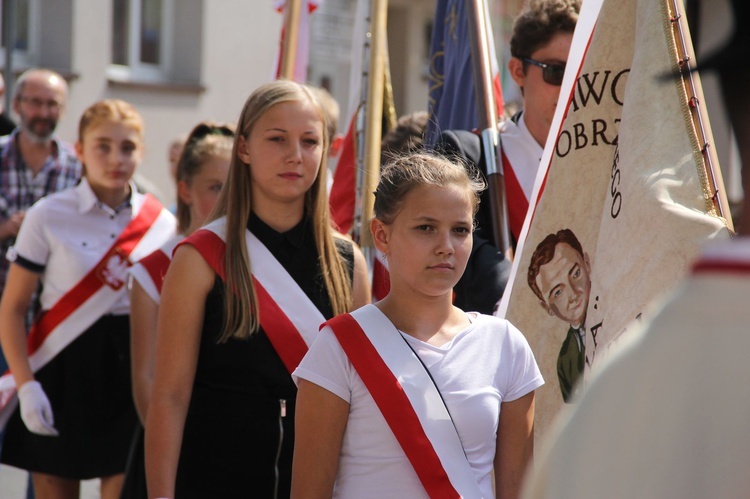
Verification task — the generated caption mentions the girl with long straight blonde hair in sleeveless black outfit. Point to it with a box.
[146,81,369,498]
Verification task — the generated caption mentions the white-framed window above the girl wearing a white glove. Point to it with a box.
[111,0,174,80]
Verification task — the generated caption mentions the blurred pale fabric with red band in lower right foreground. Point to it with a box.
[523,237,750,499]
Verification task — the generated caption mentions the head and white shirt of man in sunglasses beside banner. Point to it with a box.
[501,0,581,204]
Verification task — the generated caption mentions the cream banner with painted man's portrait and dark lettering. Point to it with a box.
[498,0,732,442]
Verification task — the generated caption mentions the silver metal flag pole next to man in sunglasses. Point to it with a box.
[467,0,513,258]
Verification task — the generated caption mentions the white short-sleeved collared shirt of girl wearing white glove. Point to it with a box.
[8,178,145,315]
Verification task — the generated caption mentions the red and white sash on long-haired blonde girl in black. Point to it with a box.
[178,218,325,374]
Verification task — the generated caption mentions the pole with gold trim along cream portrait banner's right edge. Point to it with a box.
[669,0,734,231]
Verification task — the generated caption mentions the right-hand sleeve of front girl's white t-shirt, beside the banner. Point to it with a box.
[503,321,544,402]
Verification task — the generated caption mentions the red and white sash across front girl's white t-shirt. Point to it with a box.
[326,305,481,498]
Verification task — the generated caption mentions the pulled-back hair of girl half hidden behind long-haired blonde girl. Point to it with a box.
[176,121,234,234]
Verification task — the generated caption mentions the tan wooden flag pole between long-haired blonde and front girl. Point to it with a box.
[359,0,388,252]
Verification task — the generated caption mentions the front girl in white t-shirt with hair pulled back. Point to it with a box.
[292,154,543,498]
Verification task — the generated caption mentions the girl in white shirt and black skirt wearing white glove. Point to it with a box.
[0,100,175,499]
